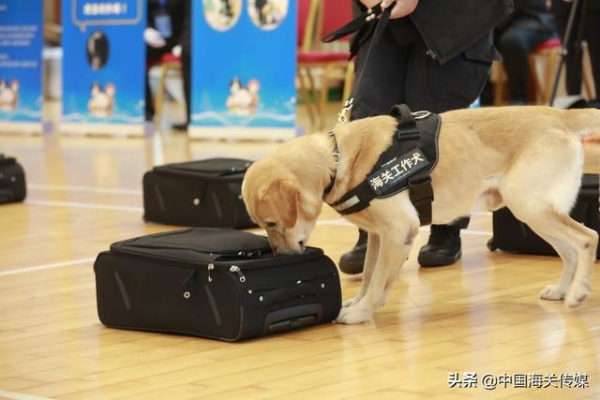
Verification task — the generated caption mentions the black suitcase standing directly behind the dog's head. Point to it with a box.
[143,158,256,229]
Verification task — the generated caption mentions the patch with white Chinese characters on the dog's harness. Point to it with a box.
[367,147,429,196]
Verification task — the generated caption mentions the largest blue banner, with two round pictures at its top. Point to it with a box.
[190,0,297,138]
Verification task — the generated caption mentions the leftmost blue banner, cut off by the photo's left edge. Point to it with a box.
[0,0,44,126]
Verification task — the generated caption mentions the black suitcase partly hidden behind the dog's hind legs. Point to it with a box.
[488,174,600,259]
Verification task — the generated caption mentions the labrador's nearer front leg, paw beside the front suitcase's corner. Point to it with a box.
[336,234,412,324]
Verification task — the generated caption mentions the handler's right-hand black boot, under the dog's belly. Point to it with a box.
[417,217,470,267]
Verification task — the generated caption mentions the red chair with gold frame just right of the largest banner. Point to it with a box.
[297,0,352,130]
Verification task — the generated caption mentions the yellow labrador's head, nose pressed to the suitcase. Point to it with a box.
[242,159,322,254]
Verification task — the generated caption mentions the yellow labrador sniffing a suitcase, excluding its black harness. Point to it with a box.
[242,106,600,324]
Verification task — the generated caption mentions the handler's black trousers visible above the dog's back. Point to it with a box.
[351,29,493,119]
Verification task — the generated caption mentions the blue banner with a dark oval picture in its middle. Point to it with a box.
[62,0,146,127]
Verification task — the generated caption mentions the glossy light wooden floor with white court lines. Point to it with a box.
[0,101,600,400]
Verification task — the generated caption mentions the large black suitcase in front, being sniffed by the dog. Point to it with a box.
[94,228,341,341]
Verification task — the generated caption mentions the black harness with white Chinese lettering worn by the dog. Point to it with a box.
[325,104,440,225]
